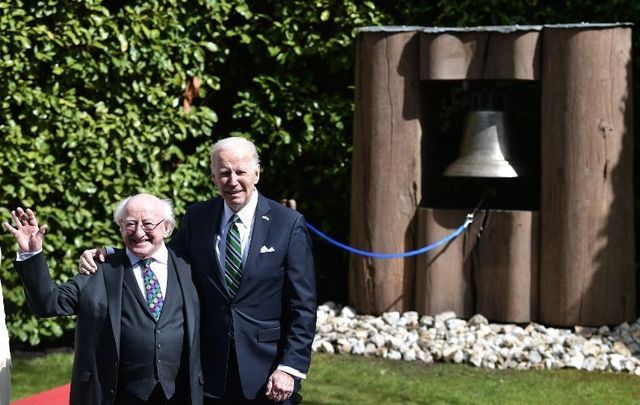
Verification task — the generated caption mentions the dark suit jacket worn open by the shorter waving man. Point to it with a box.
[14,249,203,405]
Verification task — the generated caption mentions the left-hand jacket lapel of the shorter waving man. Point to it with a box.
[100,250,126,355]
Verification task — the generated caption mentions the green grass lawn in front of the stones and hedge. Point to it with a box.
[12,353,640,405]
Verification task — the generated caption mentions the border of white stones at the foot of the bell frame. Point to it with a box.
[312,302,640,375]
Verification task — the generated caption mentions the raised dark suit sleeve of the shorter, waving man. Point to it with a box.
[14,253,92,318]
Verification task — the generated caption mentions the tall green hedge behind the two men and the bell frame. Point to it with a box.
[0,0,640,345]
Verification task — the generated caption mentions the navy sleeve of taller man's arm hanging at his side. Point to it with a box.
[280,216,316,374]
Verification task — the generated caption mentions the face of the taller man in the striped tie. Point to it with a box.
[212,147,260,212]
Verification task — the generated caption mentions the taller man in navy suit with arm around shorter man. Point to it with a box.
[81,137,316,404]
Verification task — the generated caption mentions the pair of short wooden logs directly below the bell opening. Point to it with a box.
[416,208,539,322]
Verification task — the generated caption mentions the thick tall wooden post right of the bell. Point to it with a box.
[540,26,636,326]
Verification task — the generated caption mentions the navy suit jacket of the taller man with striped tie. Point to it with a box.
[170,195,316,399]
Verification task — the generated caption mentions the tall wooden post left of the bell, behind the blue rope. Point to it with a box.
[349,32,422,314]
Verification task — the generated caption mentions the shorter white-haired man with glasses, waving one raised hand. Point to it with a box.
[4,194,203,405]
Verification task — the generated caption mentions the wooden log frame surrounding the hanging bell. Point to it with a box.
[349,23,636,326]
